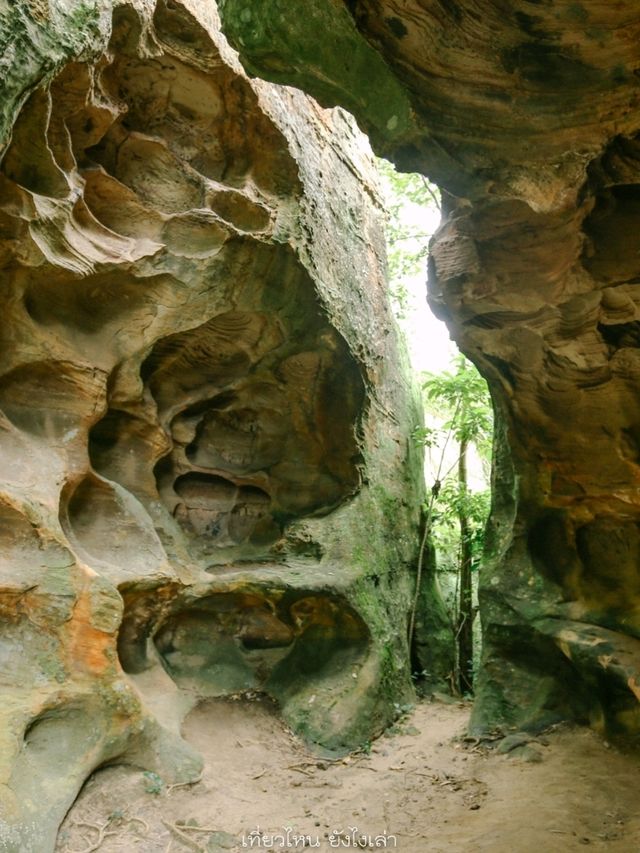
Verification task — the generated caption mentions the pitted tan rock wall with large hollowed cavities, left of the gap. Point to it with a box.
[0,0,440,853]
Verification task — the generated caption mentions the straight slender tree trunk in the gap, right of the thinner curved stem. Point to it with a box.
[457,439,473,693]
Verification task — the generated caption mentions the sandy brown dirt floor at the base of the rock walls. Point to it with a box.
[57,700,640,853]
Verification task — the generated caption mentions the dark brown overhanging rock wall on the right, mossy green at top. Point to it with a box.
[220,0,640,734]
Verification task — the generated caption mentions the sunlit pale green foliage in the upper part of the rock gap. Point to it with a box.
[377,160,440,317]
